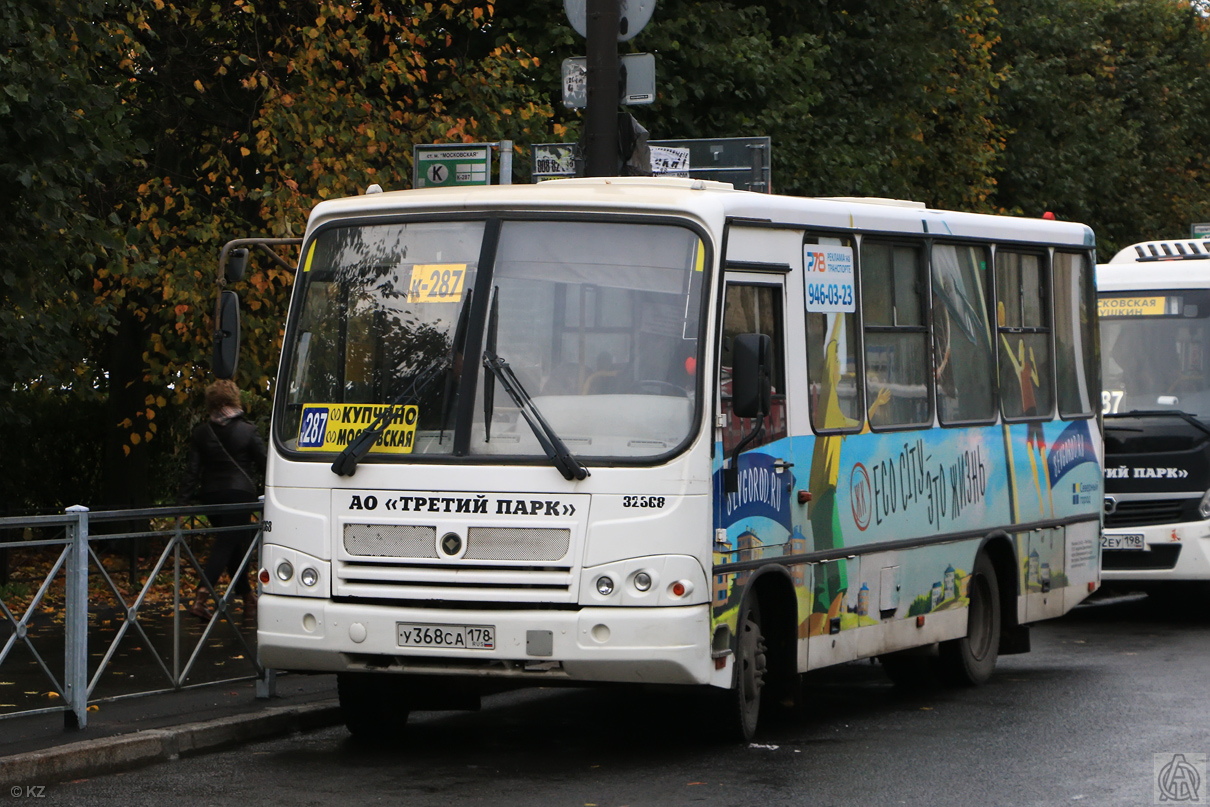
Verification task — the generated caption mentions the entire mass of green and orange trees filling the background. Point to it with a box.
[7,0,1210,507]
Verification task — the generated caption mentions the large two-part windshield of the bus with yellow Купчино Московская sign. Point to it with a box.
[276,219,704,461]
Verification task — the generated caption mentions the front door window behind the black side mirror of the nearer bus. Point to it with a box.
[719,283,787,453]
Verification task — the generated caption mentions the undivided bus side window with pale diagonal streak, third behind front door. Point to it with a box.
[932,244,996,425]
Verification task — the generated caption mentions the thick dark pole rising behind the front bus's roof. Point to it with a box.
[584,0,622,177]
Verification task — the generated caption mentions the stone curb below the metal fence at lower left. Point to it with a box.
[0,698,341,785]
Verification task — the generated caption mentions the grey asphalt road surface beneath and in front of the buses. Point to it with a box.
[28,590,1210,807]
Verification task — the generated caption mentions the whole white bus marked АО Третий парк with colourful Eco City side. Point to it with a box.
[220,178,1102,738]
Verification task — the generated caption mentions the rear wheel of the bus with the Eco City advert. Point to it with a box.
[937,553,1001,686]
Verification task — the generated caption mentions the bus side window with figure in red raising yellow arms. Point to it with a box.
[996,249,1054,419]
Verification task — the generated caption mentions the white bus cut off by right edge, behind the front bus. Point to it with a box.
[1096,240,1210,609]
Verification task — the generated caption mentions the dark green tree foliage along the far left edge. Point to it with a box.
[0,0,143,406]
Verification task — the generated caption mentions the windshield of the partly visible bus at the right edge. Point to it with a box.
[1099,290,1210,420]
